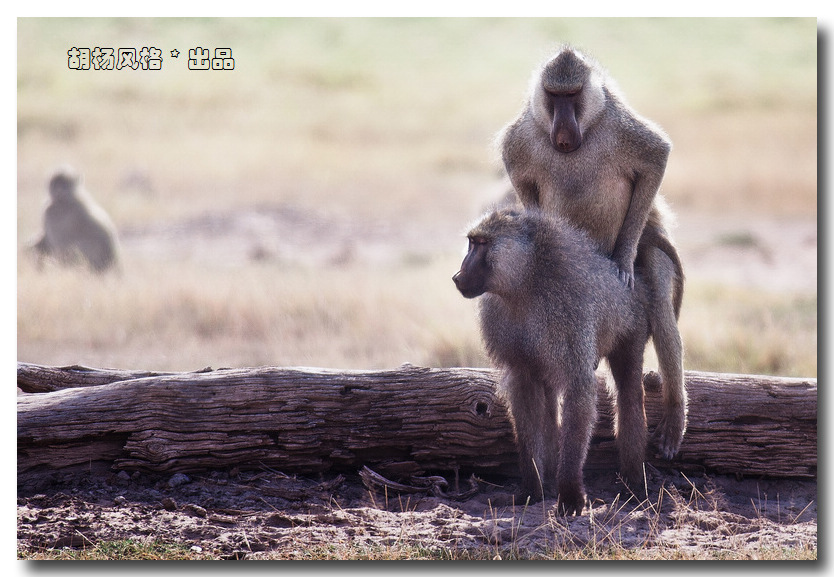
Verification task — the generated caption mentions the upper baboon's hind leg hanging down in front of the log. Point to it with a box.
[649,249,686,459]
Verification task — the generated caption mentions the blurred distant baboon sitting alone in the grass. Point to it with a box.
[34,168,119,272]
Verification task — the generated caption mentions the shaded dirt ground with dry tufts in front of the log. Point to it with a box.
[17,462,817,559]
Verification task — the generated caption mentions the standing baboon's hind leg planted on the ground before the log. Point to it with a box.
[608,339,648,489]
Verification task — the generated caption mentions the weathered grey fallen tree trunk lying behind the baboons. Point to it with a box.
[17,363,817,478]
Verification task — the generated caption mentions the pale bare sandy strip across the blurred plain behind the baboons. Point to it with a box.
[114,202,817,292]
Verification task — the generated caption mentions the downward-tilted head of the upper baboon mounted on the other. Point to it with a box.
[540,49,599,154]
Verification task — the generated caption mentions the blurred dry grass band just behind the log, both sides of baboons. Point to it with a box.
[18,250,817,377]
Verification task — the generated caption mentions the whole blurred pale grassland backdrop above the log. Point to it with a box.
[17,18,818,377]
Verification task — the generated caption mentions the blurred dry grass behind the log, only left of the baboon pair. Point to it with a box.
[18,254,483,370]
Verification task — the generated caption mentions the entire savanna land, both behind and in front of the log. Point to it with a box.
[17,18,818,559]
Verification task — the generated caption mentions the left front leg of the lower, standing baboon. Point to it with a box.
[505,371,558,501]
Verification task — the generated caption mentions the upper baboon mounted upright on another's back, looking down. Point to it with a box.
[501,46,687,459]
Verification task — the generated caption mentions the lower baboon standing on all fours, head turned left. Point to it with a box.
[452,208,674,515]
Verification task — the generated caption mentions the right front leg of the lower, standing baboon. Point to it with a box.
[558,372,597,515]
